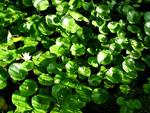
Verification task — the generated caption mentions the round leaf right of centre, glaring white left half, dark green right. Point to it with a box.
[97,50,113,65]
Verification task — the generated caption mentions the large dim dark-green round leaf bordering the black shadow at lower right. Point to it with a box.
[91,88,109,104]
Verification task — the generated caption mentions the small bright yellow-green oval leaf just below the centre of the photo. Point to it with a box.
[78,66,91,77]
